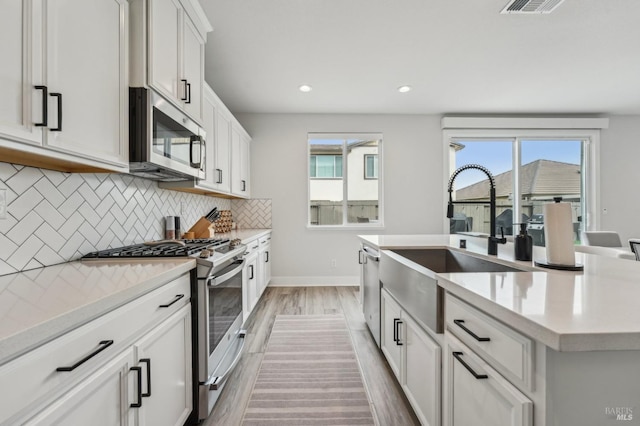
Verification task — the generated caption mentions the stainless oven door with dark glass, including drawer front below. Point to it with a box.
[199,259,245,419]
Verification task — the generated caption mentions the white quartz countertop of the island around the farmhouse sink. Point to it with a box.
[359,235,640,351]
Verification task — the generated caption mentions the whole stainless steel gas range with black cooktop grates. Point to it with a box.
[82,238,246,420]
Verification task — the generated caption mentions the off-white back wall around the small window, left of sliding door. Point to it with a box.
[236,114,446,284]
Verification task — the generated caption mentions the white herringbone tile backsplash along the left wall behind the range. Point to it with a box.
[0,162,231,275]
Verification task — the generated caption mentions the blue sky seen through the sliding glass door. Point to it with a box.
[455,140,582,189]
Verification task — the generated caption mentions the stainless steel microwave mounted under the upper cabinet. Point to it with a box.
[129,87,206,181]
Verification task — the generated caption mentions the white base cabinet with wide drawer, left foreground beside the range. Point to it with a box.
[0,274,192,425]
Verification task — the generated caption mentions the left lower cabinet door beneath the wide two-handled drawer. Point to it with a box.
[24,349,138,426]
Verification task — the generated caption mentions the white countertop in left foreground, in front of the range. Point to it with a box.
[0,259,196,365]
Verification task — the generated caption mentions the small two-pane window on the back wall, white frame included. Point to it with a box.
[308,133,382,228]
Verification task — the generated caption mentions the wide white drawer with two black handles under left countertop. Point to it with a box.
[0,274,190,424]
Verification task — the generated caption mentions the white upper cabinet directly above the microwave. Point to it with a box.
[131,0,212,124]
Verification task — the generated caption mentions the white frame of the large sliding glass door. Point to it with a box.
[442,127,600,234]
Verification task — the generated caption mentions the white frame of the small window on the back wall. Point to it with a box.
[306,132,384,231]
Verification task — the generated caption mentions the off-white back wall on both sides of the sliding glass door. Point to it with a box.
[236,114,640,284]
